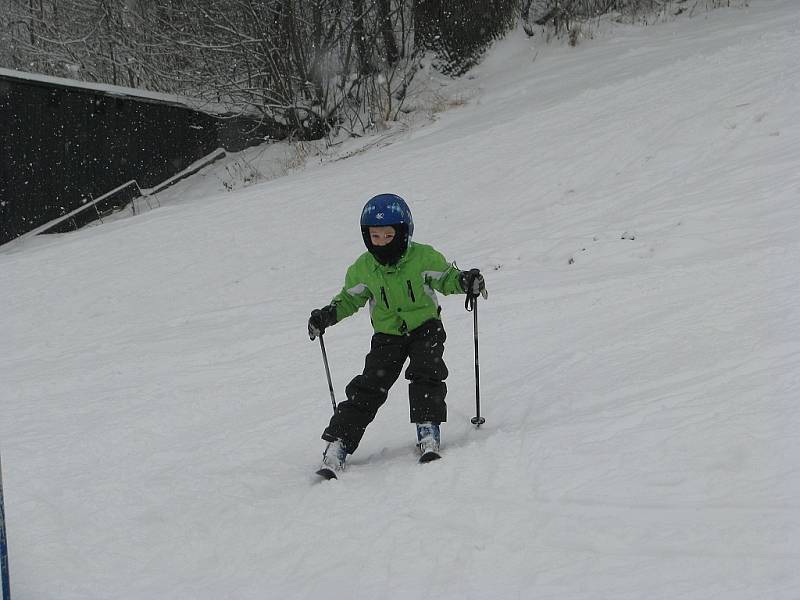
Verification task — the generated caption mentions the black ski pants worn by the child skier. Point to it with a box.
[322,319,447,454]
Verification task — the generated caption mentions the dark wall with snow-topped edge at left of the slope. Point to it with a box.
[0,75,234,244]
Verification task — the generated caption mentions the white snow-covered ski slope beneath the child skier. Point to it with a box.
[0,0,800,600]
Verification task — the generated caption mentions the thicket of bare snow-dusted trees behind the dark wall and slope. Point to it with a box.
[6,0,728,139]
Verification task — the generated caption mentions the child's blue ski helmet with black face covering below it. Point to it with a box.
[361,194,414,265]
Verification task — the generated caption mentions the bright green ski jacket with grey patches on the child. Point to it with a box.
[331,242,464,335]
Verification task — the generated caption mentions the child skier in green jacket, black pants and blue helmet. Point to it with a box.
[308,194,486,475]
